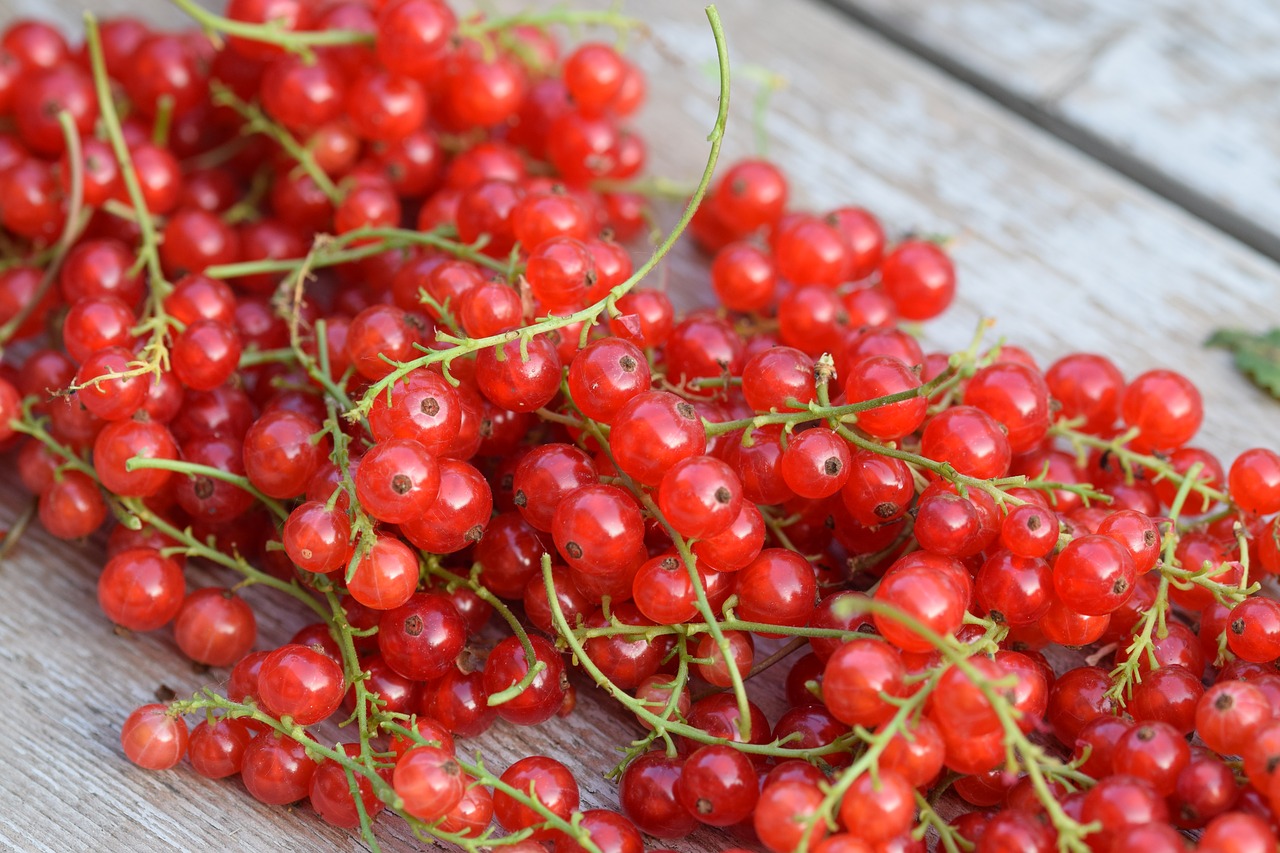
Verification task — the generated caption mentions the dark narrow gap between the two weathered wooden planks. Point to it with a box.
[817,0,1280,261]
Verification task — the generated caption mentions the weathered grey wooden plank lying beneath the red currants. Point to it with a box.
[0,0,1280,853]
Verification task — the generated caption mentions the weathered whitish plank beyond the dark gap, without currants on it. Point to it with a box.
[827,0,1280,257]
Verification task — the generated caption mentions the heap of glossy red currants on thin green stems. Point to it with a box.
[0,0,1280,853]
